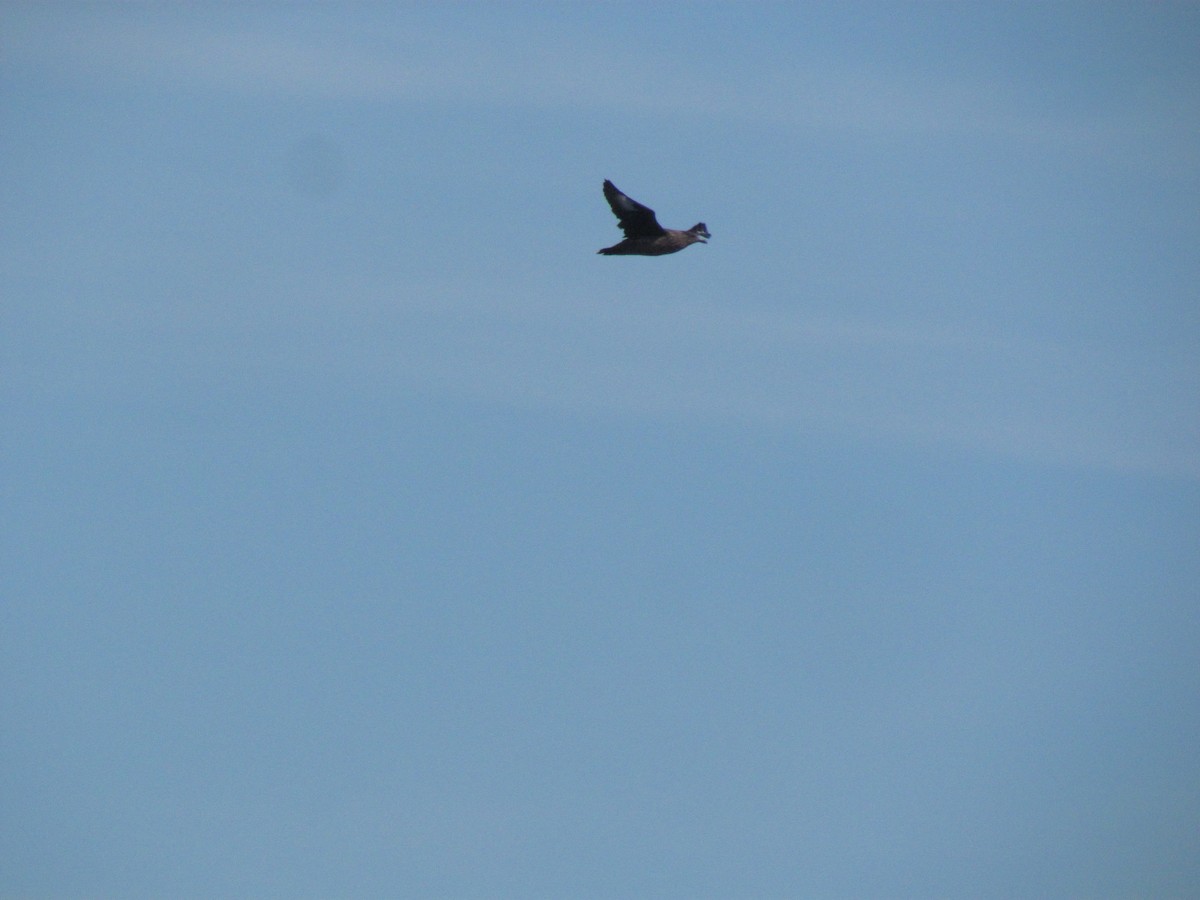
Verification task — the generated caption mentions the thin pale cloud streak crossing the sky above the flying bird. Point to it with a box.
[6,13,1200,167]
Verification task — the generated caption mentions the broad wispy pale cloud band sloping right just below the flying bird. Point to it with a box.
[175,274,1200,479]
